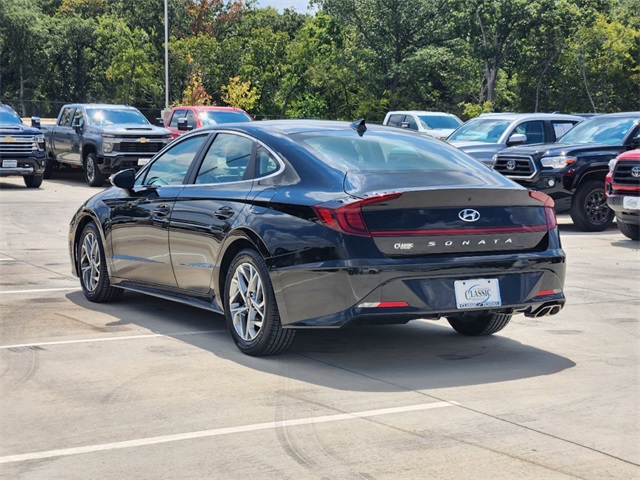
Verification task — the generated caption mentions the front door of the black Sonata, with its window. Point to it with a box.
[111,133,208,288]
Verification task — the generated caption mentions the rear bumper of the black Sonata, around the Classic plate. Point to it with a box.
[271,248,565,328]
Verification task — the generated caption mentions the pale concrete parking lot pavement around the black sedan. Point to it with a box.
[0,174,640,480]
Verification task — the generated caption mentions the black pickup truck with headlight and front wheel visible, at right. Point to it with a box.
[493,112,640,232]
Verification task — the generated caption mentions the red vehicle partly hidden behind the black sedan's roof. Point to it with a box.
[166,105,252,139]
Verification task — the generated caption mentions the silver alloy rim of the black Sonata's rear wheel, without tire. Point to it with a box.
[228,262,266,341]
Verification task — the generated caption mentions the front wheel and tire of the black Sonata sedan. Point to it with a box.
[77,222,123,303]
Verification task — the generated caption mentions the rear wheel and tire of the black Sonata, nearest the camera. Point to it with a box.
[224,249,296,357]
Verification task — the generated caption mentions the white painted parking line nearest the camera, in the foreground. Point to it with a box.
[0,401,460,464]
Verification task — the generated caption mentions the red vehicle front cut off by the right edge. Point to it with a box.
[605,149,640,240]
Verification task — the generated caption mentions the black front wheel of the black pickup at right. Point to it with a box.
[569,180,615,232]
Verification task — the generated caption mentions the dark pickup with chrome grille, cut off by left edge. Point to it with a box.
[0,103,46,188]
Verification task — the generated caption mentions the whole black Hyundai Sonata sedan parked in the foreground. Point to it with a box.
[69,121,565,356]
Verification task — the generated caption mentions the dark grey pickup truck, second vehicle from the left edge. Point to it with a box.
[43,104,171,187]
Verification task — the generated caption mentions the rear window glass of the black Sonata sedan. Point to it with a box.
[291,131,482,172]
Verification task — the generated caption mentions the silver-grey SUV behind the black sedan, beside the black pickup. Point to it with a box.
[447,113,584,166]
